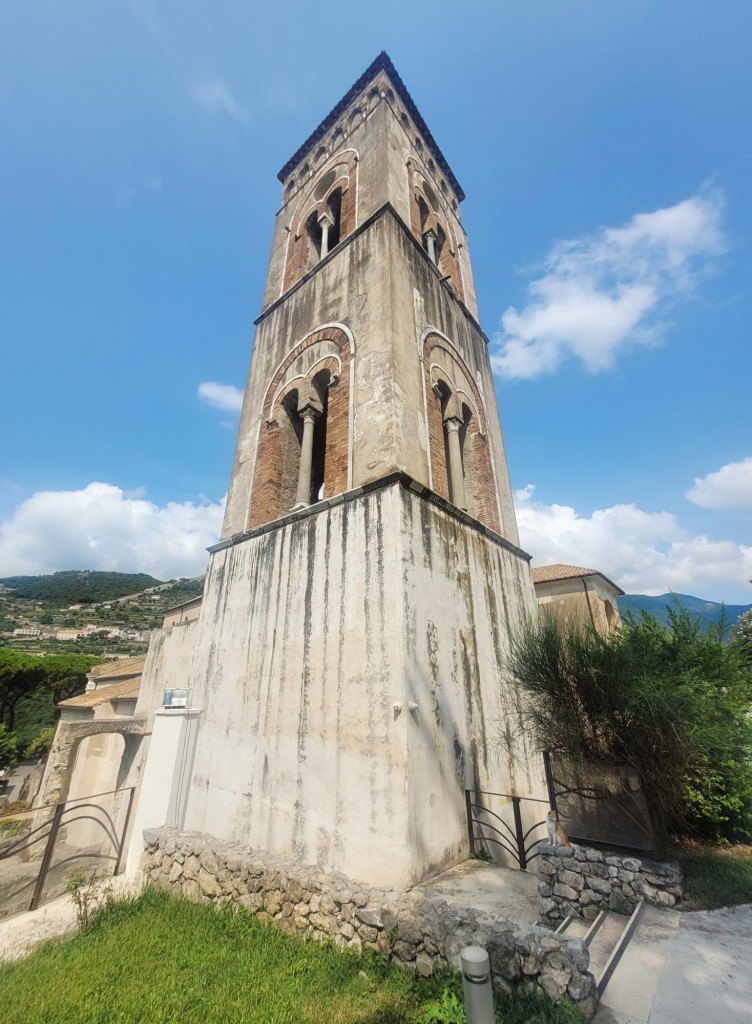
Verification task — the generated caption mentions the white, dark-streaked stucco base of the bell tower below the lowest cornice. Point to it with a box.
[174,478,534,884]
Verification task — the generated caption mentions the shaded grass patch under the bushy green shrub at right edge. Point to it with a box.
[671,840,752,910]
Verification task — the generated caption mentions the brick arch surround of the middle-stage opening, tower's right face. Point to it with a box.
[423,332,501,534]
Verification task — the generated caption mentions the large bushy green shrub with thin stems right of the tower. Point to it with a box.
[510,602,752,841]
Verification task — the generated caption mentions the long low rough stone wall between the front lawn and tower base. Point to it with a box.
[141,827,595,1019]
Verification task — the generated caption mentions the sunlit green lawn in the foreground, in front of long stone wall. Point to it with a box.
[0,889,581,1024]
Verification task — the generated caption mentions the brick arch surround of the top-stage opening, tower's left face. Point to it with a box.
[282,150,358,292]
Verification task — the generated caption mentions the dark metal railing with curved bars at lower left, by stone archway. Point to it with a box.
[0,786,135,916]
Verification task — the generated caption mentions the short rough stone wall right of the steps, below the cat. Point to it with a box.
[538,843,682,923]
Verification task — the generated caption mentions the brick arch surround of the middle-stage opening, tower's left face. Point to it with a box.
[248,328,352,529]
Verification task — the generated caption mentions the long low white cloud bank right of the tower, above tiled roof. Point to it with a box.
[515,485,752,597]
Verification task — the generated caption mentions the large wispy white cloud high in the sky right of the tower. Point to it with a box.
[491,191,723,378]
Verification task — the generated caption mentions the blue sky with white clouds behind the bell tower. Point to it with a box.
[0,0,752,603]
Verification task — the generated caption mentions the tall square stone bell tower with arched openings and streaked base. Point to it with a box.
[131,53,535,885]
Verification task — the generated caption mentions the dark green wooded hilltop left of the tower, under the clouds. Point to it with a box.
[0,569,162,608]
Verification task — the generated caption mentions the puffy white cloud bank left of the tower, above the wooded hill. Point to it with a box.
[0,483,224,580]
